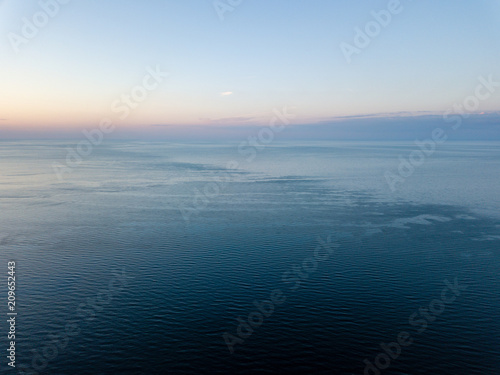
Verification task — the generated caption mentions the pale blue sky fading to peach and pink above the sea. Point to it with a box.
[0,0,500,139]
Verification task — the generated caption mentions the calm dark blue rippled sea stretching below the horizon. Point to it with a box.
[0,142,500,375]
